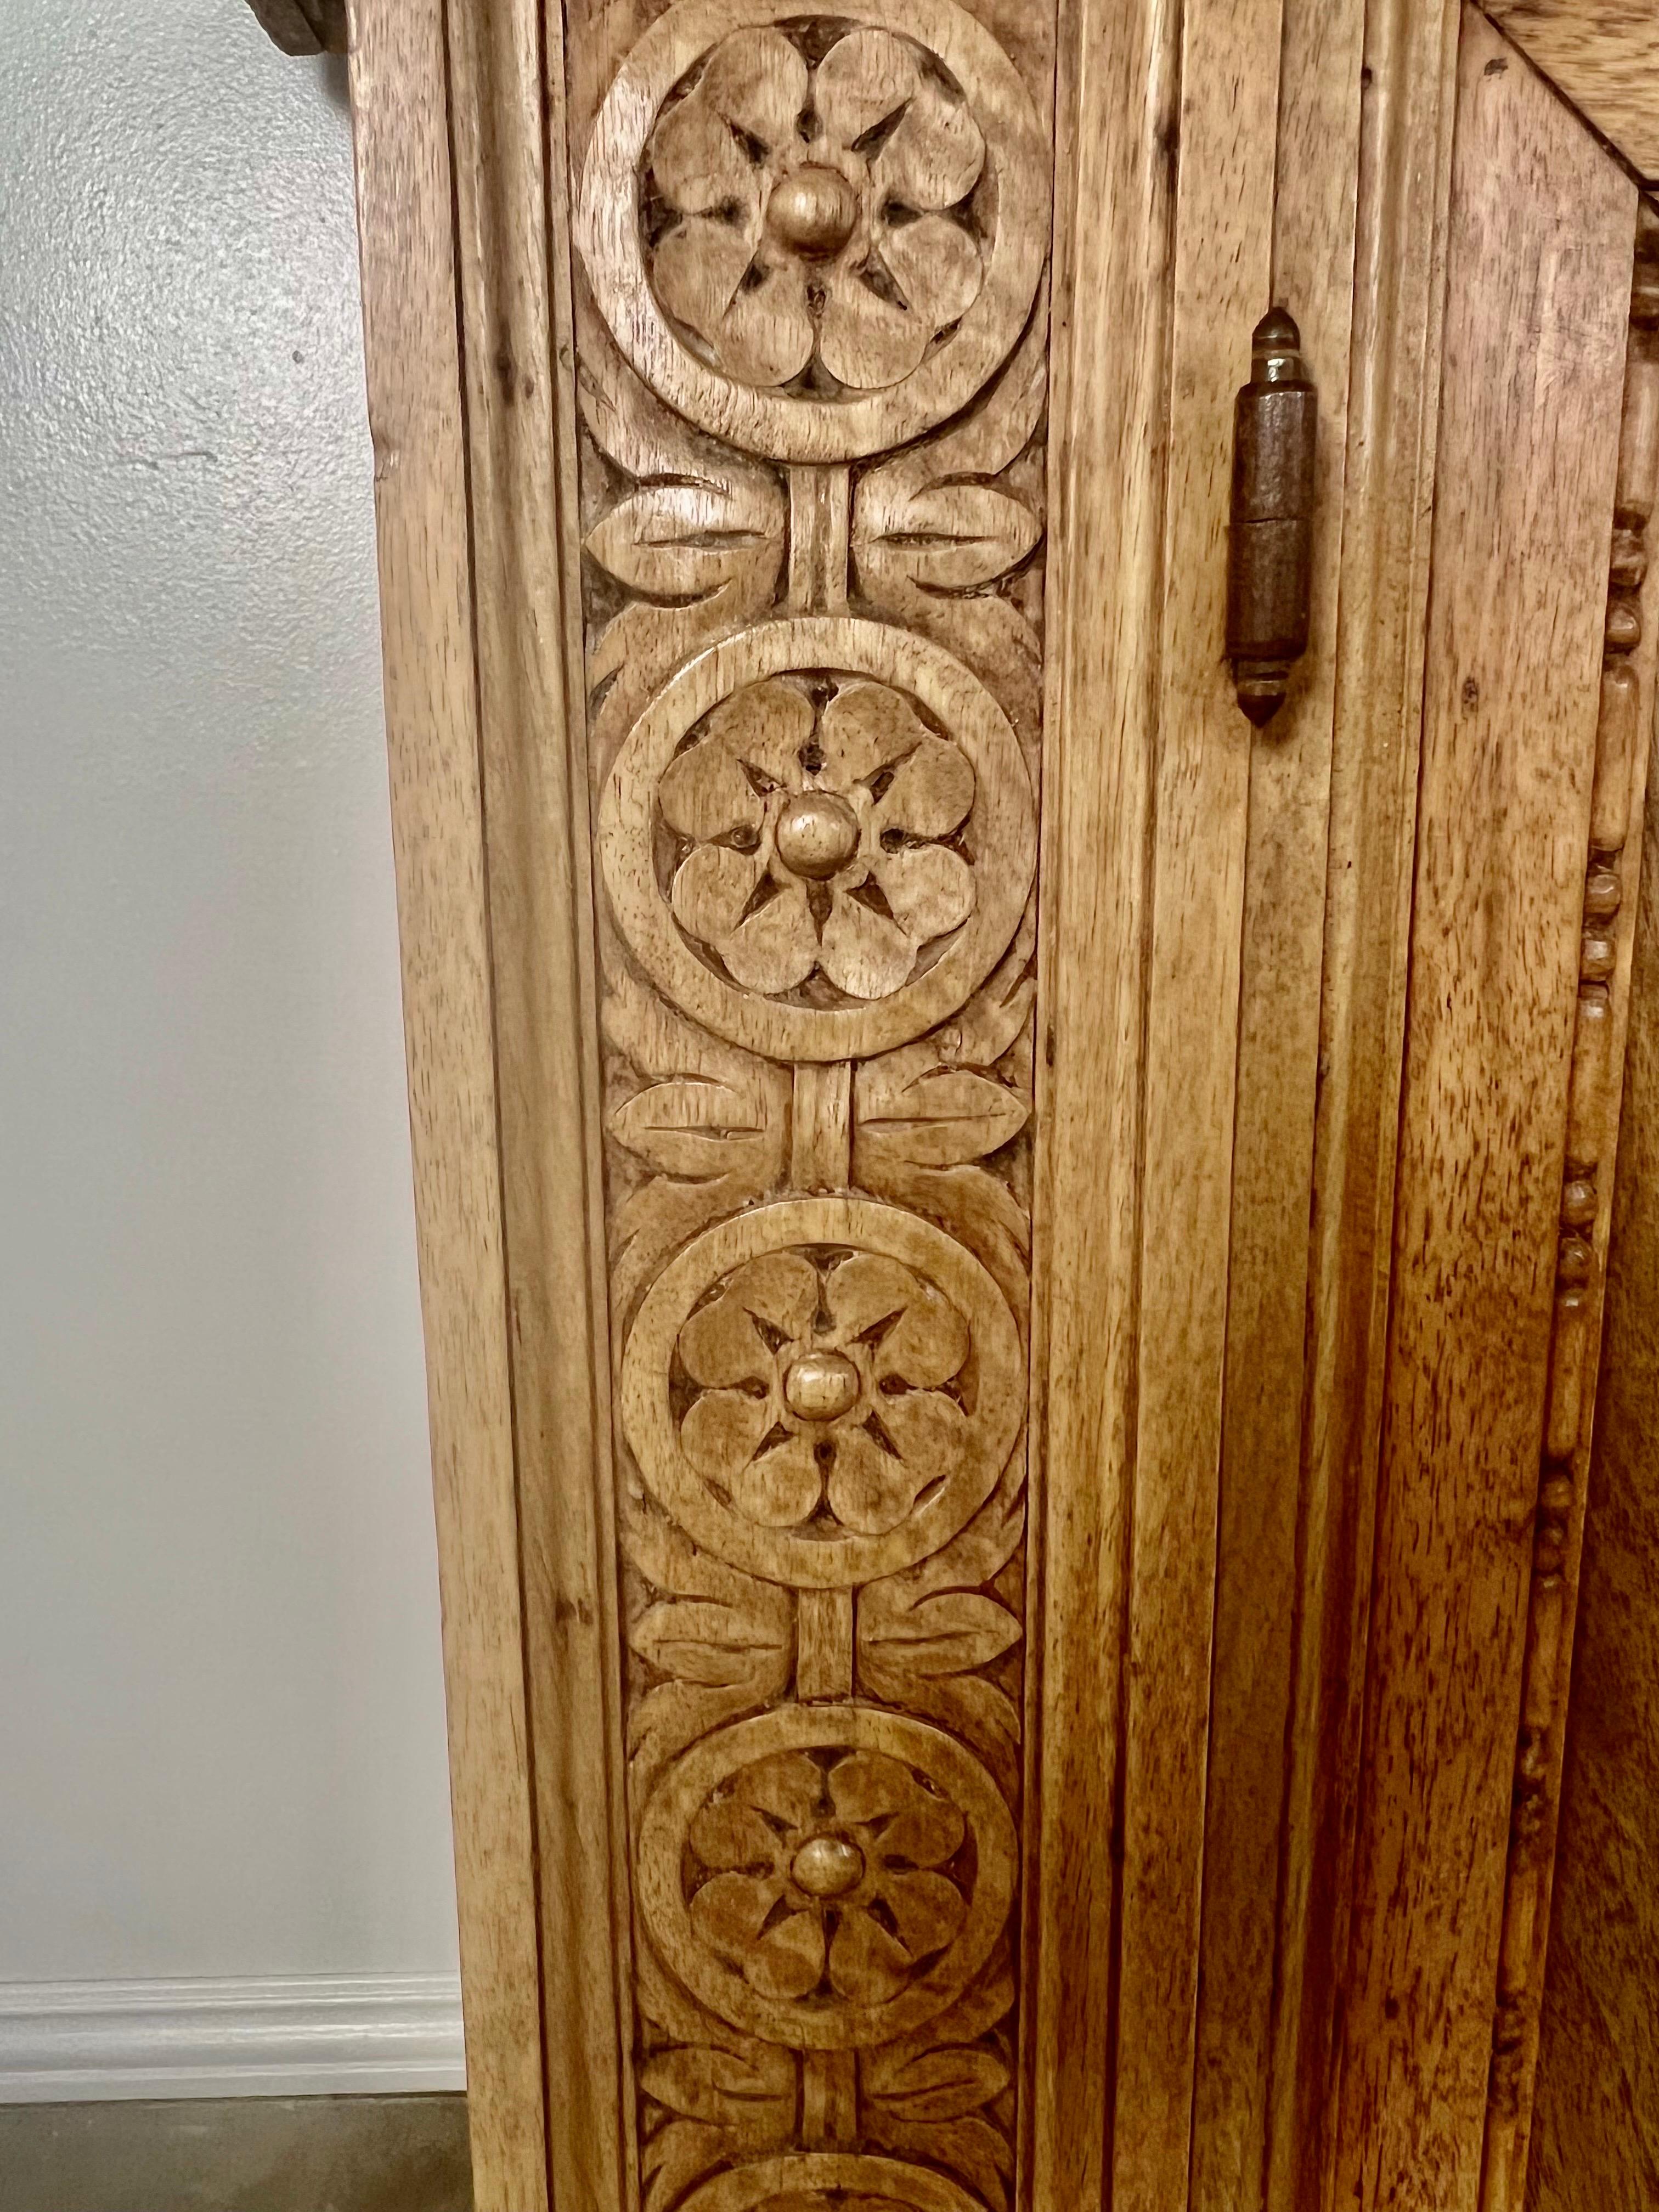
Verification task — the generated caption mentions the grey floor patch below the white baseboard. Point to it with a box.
[0,2097,473,2212]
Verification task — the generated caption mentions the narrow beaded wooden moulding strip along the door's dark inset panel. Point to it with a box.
[1482,204,1659,2212]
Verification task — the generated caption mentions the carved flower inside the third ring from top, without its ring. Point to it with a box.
[679,1252,969,1535]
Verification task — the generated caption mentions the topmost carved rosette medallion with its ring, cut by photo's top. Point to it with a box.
[577,0,1048,462]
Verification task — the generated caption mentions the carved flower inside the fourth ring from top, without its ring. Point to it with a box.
[690,1750,967,2004]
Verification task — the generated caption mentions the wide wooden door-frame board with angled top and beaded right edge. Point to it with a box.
[1336,9,1659,2212]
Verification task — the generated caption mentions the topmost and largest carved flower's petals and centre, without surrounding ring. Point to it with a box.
[646,29,984,392]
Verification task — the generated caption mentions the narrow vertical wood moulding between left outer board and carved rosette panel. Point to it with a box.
[447,0,630,2212]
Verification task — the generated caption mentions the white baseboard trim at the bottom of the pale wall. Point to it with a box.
[0,1973,467,2103]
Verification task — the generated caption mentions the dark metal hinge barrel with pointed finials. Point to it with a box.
[1228,307,1318,728]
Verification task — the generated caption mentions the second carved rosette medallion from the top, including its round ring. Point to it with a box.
[600,615,1037,1059]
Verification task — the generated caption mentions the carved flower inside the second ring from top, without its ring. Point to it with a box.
[659,677,975,1000]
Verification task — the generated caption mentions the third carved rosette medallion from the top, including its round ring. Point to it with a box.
[622,1199,1024,1590]
